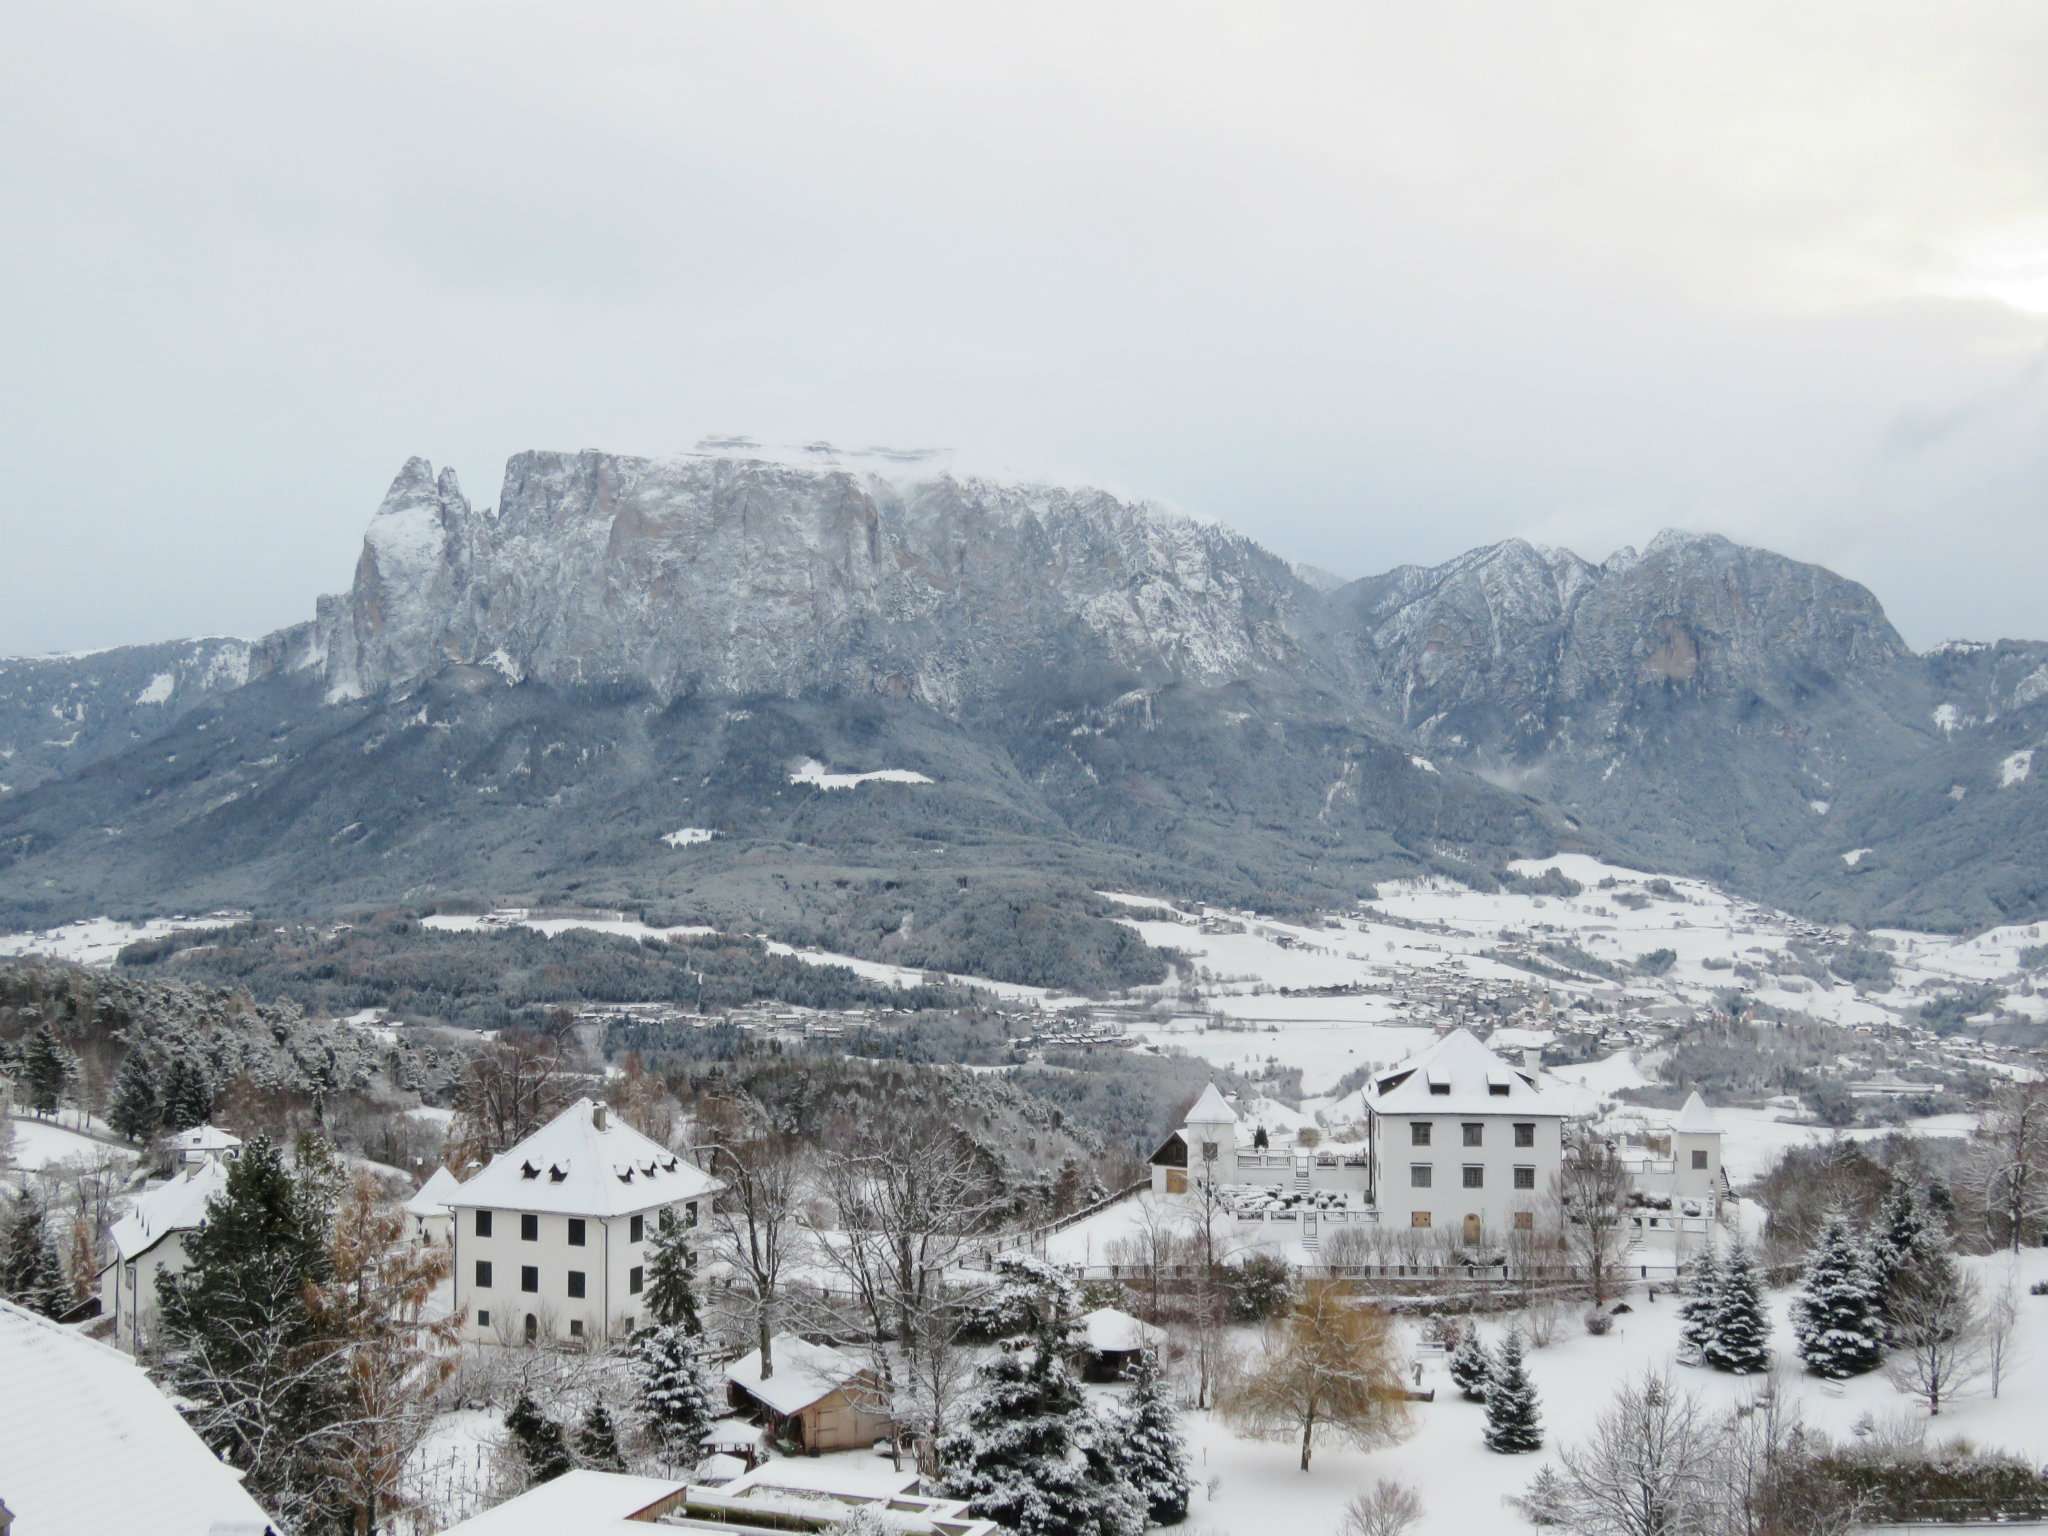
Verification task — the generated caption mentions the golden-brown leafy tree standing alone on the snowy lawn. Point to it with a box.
[1225,1280,1407,1473]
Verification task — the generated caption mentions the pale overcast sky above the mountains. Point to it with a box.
[0,0,2048,653]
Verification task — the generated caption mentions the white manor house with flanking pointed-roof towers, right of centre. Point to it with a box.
[1151,1028,1726,1253]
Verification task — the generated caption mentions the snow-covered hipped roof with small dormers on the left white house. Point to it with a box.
[442,1098,725,1217]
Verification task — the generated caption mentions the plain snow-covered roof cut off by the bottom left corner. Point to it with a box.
[0,1300,272,1536]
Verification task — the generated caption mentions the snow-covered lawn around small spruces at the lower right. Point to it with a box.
[1182,1249,2048,1536]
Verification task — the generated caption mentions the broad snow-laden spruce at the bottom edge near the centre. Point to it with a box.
[938,1325,1145,1536]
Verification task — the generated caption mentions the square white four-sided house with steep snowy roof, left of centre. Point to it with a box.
[444,1098,723,1343]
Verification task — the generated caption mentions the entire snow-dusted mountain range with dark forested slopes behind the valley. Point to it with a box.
[0,453,2048,979]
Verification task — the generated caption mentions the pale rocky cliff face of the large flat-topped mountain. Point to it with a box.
[317,453,1315,711]
